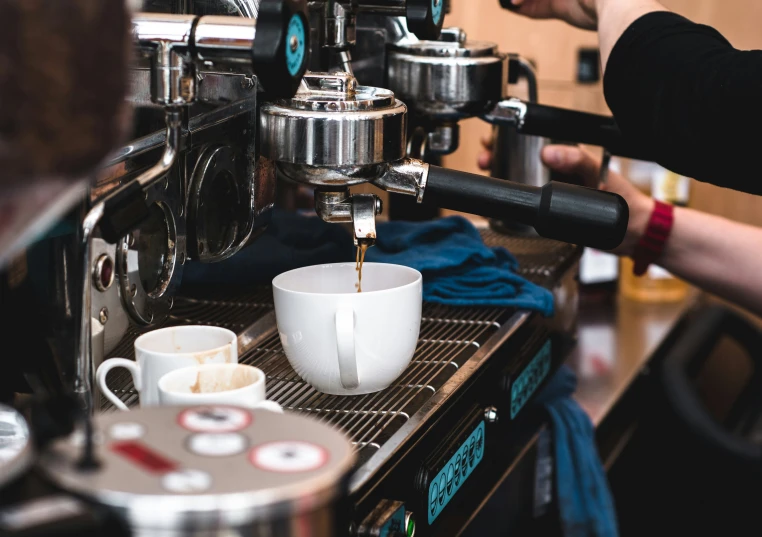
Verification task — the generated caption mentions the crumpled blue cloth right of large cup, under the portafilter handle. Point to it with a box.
[365,216,553,316]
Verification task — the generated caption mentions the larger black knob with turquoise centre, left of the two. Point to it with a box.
[252,0,310,98]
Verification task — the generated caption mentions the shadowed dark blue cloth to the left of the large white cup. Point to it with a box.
[183,210,355,285]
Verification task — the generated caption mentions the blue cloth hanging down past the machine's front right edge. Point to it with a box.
[535,365,618,537]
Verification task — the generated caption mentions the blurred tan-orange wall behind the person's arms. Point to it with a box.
[445,0,762,226]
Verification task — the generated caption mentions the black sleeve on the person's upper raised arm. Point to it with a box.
[604,12,762,194]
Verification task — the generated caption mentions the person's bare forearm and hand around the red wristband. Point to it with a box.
[542,146,762,314]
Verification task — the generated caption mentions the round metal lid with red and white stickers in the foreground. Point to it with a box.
[41,405,355,530]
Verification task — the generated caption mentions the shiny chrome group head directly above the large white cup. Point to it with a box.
[260,73,407,170]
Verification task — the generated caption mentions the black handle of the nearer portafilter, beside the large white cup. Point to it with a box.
[424,166,630,250]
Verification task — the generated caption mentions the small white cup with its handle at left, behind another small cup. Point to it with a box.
[95,326,238,410]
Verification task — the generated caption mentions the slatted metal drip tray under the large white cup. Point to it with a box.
[102,230,579,488]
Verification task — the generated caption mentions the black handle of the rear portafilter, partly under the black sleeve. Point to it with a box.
[518,103,655,161]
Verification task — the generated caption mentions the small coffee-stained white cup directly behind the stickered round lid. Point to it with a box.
[159,364,283,413]
